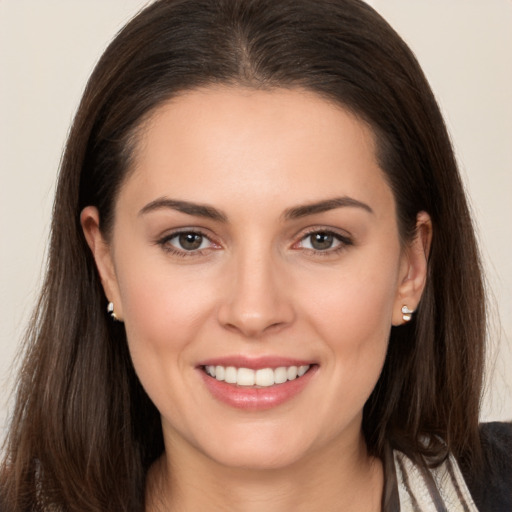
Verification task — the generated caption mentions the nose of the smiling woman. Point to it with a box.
[218,251,295,339]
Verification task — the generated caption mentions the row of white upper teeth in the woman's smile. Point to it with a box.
[205,364,310,387]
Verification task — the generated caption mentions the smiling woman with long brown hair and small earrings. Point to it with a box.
[0,0,511,511]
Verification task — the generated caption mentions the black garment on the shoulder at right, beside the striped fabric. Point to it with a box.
[461,422,512,512]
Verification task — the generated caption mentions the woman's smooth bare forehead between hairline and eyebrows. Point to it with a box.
[122,87,390,216]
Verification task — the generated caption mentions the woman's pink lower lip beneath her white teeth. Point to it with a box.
[198,365,318,411]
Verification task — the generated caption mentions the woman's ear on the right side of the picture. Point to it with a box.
[392,212,432,325]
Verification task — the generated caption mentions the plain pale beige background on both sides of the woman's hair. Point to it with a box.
[0,0,512,437]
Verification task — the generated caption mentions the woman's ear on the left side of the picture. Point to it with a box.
[80,206,123,320]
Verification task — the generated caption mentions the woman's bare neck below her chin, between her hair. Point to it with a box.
[146,435,383,512]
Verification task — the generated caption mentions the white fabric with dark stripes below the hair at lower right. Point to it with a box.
[392,450,478,512]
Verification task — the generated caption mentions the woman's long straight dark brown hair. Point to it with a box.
[0,0,485,512]
